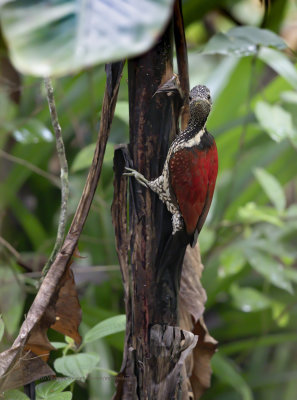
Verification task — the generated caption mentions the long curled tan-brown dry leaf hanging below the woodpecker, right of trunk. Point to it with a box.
[179,244,217,400]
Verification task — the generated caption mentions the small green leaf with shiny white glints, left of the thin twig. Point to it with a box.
[12,119,54,144]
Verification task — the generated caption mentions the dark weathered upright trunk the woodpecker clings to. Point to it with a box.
[112,15,197,400]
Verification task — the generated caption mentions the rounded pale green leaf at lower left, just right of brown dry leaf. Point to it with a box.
[54,353,100,381]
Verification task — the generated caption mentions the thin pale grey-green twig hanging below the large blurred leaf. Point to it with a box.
[42,78,69,277]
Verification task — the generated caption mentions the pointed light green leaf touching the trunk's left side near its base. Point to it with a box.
[84,315,126,343]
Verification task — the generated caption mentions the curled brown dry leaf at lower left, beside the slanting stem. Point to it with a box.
[0,255,81,391]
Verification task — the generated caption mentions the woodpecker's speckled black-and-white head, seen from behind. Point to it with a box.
[189,85,212,122]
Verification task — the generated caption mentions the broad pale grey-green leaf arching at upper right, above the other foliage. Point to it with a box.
[203,26,287,57]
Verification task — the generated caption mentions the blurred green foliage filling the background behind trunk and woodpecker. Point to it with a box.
[0,0,297,400]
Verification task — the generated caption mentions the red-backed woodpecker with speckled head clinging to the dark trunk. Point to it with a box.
[125,79,218,247]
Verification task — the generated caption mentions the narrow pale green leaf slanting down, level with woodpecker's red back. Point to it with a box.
[254,168,286,212]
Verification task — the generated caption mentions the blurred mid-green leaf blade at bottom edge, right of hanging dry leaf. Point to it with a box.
[211,353,253,400]
